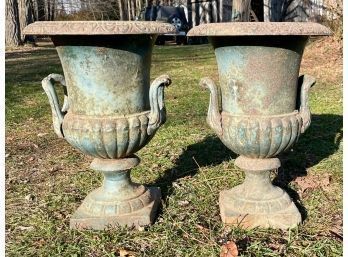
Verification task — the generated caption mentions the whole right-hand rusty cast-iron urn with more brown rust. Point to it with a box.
[189,22,331,229]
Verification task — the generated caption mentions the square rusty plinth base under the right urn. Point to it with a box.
[219,191,301,230]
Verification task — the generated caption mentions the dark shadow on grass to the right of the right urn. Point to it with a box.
[273,114,343,221]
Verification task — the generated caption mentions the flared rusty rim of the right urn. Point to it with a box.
[187,22,332,37]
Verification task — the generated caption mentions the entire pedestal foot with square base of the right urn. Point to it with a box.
[219,156,301,229]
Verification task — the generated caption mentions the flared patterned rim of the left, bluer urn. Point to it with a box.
[23,21,176,36]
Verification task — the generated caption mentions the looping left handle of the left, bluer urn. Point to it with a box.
[42,74,69,138]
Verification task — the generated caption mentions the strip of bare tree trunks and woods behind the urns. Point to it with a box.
[5,0,343,46]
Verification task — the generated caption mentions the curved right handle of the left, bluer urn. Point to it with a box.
[147,75,172,135]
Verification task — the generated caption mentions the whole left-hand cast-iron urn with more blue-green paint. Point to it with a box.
[24,21,175,230]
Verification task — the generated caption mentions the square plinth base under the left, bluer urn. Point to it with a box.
[70,187,161,230]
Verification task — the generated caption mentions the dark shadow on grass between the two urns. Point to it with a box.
[154,136,236,201]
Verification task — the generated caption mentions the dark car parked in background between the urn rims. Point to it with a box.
[138,5,190,45]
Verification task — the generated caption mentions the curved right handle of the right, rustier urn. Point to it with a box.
[298,75,315,133]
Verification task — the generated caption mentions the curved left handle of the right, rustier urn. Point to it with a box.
[199,77,222,136]
